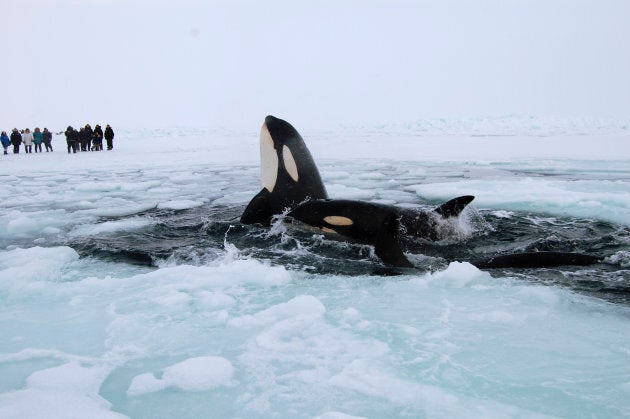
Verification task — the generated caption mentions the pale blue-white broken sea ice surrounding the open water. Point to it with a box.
[0,123,630,418]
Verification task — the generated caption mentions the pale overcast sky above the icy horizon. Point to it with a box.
[0,0,630,129]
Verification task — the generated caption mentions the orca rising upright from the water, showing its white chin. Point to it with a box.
[241,115,328,225]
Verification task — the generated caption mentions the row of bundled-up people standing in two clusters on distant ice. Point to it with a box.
[0,124,114,154]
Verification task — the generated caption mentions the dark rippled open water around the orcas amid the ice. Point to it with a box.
[68,204,630,305]
